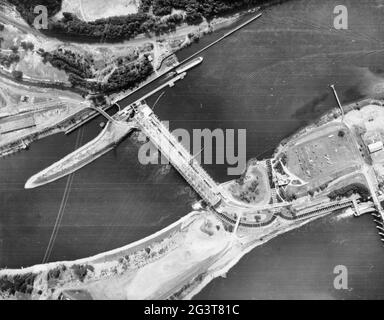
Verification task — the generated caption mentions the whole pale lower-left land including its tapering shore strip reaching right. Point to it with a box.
[0,202,336,299]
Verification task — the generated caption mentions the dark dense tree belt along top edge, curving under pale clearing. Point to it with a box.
[8,0,276,41]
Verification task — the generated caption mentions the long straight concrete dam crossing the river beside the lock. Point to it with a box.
[132,101,222,207]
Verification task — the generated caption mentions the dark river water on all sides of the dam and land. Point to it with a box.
[0,0,384,299]
